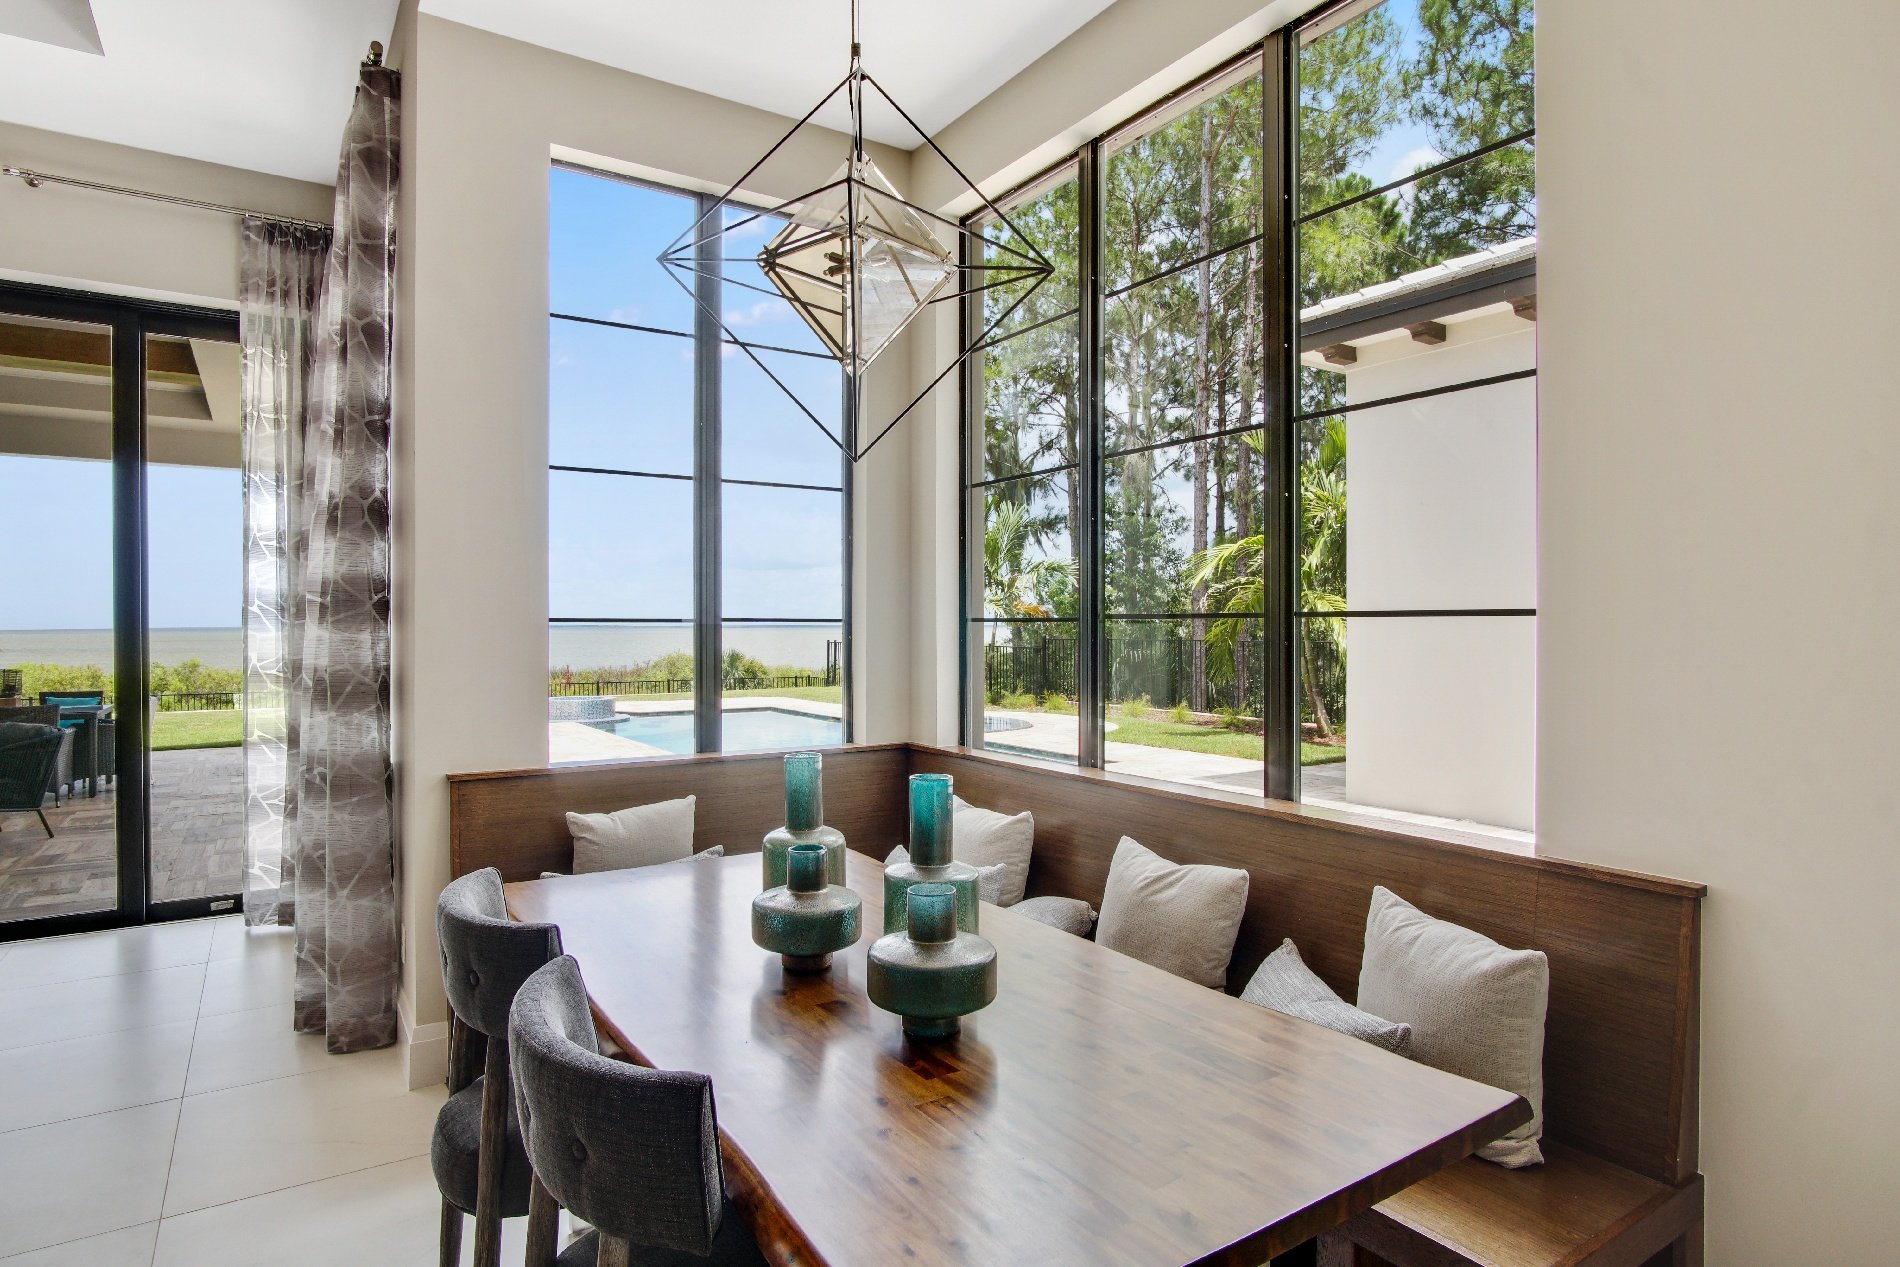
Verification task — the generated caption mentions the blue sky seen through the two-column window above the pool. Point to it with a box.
[547,169,842,619]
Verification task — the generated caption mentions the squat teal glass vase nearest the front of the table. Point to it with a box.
[865,883,996,1039]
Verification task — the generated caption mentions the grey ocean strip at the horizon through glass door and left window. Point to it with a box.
[0,625,842,671]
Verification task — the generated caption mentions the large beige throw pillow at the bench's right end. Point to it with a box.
[1359,889,1550,1168]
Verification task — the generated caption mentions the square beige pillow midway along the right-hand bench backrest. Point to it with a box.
[1094,836,1246,990]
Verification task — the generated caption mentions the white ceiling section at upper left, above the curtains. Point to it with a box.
[0,0,397,184]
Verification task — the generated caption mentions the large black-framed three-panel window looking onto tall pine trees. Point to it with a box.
[965,0,1537,834]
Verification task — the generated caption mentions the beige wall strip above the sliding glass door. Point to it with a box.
[0,123,334,308]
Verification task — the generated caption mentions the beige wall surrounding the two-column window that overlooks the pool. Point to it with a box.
[395,13,910,1085]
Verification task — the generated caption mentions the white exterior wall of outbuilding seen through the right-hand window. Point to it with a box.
[1345,308,1537,830]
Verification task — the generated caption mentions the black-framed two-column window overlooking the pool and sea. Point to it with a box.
[547,165,847,762]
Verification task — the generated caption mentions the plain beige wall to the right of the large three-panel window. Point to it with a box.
[1537,0,1900,1265]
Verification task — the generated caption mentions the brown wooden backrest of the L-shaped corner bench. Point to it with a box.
[450,745,1702,1183]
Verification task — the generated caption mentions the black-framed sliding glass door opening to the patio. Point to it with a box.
[0,285,245,940]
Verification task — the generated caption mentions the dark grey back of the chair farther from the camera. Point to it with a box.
[435,866,561,1039]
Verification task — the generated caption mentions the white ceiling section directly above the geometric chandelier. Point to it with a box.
[422,0,1113,150]
